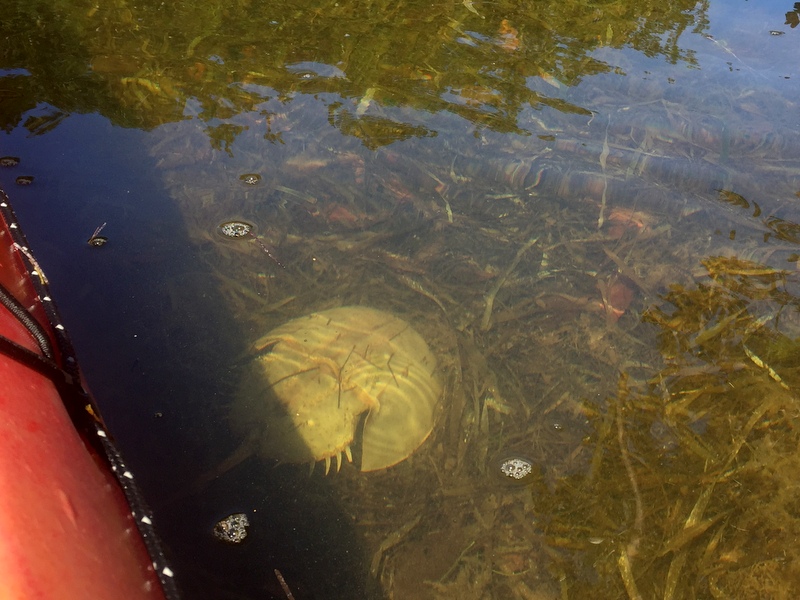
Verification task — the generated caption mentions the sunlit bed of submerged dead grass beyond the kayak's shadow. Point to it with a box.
[147,48,800,600]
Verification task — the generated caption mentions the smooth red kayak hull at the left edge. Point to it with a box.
[0,195,164,600]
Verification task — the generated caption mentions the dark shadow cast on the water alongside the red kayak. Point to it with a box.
[0,116,378,600]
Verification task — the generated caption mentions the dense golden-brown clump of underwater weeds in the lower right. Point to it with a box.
[534,257,800,599]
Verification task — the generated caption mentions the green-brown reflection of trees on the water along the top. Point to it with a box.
[0,0,706,147]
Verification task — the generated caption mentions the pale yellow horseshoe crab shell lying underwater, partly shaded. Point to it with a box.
[232,306,442,473]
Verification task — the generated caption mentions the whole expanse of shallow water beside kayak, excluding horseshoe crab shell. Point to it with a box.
[0,2,800,599]
